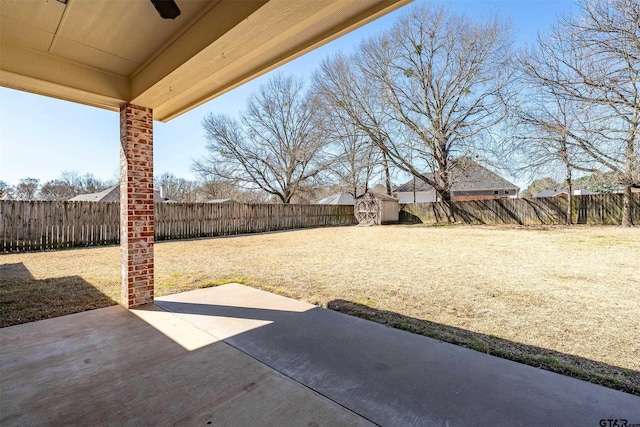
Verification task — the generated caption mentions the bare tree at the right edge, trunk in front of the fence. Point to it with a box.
[526,0,640,226]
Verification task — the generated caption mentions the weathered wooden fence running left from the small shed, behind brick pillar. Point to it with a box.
[0,200,354,252]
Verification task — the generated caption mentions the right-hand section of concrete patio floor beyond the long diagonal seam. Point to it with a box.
[156,285,640,426]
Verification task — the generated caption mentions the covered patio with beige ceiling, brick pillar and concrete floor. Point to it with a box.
[0,0,640,426]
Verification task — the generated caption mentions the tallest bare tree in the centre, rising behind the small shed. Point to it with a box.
[314,4,512,217]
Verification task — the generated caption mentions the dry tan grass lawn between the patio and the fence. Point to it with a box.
[0,225,640,394]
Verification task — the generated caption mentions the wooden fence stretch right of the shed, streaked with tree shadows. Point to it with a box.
[400,193,640,225]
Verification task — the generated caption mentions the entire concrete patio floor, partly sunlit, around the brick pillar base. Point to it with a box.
[0,284,640,426]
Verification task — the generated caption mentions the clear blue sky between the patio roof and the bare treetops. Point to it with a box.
[0,0,573,185]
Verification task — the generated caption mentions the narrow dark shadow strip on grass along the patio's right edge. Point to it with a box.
[328,299,640,396]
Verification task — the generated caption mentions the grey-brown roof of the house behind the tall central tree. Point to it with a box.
[394,158,519,193]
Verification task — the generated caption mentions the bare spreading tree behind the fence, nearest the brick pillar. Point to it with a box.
[193,74,327,203]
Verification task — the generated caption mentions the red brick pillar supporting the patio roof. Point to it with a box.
[120,104,153,308]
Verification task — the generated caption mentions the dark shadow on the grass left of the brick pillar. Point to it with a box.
[0,262,116,328]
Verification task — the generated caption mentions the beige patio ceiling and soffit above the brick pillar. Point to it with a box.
[0,0,410,121]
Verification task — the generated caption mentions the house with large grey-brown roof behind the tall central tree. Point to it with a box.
[393,158,520,203]
